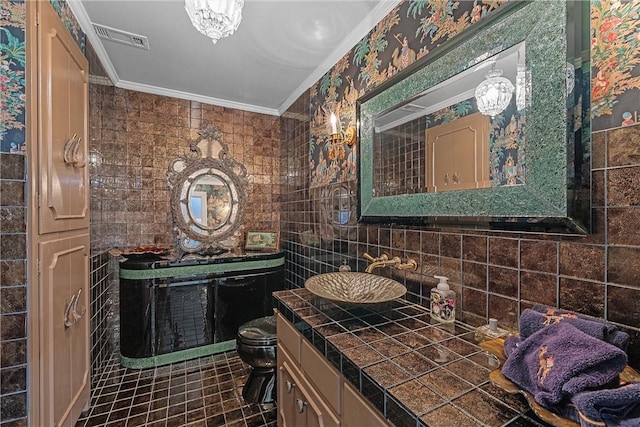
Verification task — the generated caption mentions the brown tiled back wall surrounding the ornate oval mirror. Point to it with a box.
[90,85,280,248]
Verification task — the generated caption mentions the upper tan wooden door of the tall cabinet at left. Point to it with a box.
[35,2,89,234]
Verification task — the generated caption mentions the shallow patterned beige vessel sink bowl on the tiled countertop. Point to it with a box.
[304,271,407,304]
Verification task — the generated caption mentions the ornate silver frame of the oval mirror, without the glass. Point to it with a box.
[167,124,247,253]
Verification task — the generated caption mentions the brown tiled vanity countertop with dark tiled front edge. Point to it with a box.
[273,289,547,427]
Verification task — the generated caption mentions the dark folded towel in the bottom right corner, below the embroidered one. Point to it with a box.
[571,383,640,427]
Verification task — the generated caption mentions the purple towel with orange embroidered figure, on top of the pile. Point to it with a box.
[502,322,627,409]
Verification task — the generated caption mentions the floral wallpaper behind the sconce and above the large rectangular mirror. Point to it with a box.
[310,0,506,187]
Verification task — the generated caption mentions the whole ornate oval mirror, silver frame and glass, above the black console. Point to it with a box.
[167,125,247,254]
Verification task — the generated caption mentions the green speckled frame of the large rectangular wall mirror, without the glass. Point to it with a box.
[357,1,590,234]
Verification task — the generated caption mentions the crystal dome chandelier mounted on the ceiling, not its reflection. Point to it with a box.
[184,0,244,43]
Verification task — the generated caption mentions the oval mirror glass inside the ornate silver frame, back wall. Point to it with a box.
[189,175,231,229]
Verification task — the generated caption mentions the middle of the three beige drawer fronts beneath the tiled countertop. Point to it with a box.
[300,340,341,414]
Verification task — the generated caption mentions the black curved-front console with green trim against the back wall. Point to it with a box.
[120,252,284,368]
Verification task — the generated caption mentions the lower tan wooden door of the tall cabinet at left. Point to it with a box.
[38,234,90,426]
